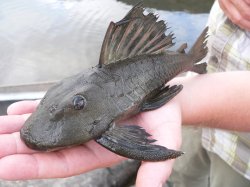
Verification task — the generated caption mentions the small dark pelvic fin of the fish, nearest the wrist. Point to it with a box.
[141,85,183,111]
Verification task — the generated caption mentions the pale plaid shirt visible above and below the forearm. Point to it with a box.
[202,1,250,180]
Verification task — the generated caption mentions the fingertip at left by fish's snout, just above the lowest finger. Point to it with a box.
[0,132,36,158]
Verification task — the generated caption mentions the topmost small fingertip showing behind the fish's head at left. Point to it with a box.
[7,100,40,115]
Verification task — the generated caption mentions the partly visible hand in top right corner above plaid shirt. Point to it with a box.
[219,0,250,31]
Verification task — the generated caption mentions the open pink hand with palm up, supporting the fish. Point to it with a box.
[0,101,181,187]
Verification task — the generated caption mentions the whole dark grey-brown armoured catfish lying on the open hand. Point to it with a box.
[21,4,207,161]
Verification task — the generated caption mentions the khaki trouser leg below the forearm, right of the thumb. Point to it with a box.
[169,127,210,187]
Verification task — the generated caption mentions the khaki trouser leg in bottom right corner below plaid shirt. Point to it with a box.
[208,152,250,187]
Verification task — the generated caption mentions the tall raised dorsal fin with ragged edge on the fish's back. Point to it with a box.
[99,3,173,66]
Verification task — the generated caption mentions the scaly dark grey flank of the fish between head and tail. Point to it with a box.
[101,54,193,118]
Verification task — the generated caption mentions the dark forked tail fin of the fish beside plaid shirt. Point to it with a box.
[188,27,208,74]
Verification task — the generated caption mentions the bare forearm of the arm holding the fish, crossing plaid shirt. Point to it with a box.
[176,71,250,131]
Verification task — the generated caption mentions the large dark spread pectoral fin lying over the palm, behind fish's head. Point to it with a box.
[96,122,183,161]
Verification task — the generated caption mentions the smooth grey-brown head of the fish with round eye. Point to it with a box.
[20,75,111,151]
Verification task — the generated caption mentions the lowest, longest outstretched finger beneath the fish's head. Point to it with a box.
[0,141,122,180]
